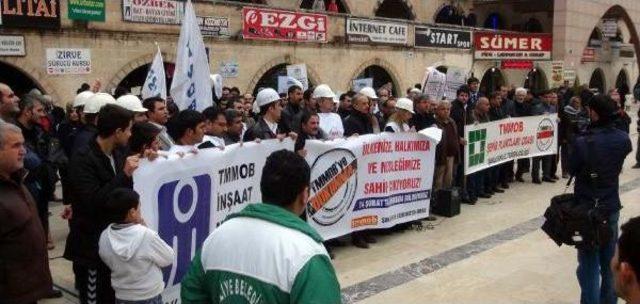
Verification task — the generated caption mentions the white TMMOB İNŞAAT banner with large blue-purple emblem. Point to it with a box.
[133,139,293,303]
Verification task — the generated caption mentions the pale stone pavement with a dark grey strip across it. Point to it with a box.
[42,106,640,304]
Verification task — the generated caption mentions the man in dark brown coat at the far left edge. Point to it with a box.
[0,120,61,304]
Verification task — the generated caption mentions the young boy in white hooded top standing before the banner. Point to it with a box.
[99,188,174,304]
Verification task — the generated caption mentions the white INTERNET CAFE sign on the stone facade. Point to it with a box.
[346,18,409,45]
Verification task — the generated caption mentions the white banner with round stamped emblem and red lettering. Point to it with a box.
[305,128,441,239]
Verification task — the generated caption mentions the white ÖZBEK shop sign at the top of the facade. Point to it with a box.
[122,0,184,24]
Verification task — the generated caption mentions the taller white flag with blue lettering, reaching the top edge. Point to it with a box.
[171,0,213,111]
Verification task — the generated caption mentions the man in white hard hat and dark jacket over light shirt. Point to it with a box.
[243,88,296,141]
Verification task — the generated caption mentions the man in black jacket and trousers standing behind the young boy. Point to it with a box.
[64,105,139,303]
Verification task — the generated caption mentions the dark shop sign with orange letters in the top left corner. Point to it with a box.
[0,0,60,29]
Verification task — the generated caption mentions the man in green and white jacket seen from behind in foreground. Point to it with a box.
[181,150,341,304]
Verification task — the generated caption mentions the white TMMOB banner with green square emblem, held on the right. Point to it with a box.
[464,114,558,175]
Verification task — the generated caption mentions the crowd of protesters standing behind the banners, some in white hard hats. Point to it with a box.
[0,77,640,303]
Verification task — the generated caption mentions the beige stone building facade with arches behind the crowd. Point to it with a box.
[0,0,640,103]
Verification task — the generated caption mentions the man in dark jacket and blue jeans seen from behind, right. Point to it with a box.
[569,95,631,304]
